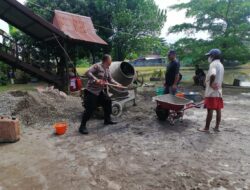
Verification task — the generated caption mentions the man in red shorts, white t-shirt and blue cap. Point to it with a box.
[199,49,224,132]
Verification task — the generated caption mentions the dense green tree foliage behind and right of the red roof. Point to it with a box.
[26,0,166,60]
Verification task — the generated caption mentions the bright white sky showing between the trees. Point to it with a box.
[0,0,209,43]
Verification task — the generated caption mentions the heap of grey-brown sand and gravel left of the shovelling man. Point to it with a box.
[0,91,83,126]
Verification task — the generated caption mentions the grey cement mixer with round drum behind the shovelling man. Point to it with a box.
[82,62,144,117]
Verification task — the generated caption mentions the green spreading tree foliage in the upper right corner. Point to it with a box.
[169,0,250,63]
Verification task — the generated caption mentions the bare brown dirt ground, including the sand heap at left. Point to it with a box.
[0,86,250,190]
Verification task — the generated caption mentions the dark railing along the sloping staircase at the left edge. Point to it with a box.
[0,33,57,73]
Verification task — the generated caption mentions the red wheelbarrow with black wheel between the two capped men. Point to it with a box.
[153,94,203,125]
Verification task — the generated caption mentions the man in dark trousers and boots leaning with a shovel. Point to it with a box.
[79,54,121,134]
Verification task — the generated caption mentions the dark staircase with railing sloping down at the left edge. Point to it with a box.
[0,34,64,87]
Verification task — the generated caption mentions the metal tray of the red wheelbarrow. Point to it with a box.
[154,94,193,111]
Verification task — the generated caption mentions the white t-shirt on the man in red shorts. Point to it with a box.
[205,60,224,97]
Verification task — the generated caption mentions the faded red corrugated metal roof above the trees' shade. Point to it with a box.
[53,10,107,45]
